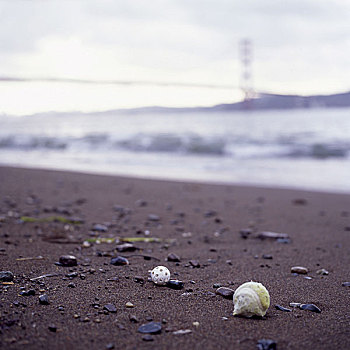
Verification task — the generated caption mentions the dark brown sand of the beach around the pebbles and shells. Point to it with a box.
[0,167,350,350]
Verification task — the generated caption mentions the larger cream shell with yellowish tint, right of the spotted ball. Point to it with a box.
[233,281,270,317]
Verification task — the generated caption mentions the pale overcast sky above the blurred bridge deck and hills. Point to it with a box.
[0,0,350,113]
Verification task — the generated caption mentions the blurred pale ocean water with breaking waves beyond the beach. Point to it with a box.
[0,109,350,193]
